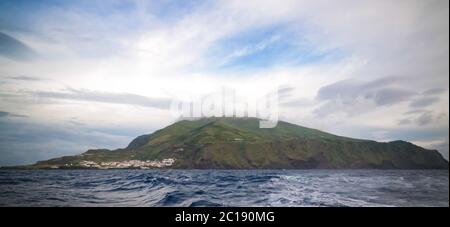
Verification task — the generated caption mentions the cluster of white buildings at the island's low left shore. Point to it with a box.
[80,158,175,169]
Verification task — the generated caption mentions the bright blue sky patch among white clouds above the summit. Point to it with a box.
[207,25,343,69]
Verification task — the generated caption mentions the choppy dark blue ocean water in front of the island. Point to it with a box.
[0,170,449,207]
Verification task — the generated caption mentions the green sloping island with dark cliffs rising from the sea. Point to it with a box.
[29,118,449,169]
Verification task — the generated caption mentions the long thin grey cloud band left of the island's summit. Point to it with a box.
[33,89,171,109]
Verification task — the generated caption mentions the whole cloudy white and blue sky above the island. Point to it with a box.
[0,0,449,165]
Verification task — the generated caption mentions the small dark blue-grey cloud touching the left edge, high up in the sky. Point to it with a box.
[0,32,36,61]
